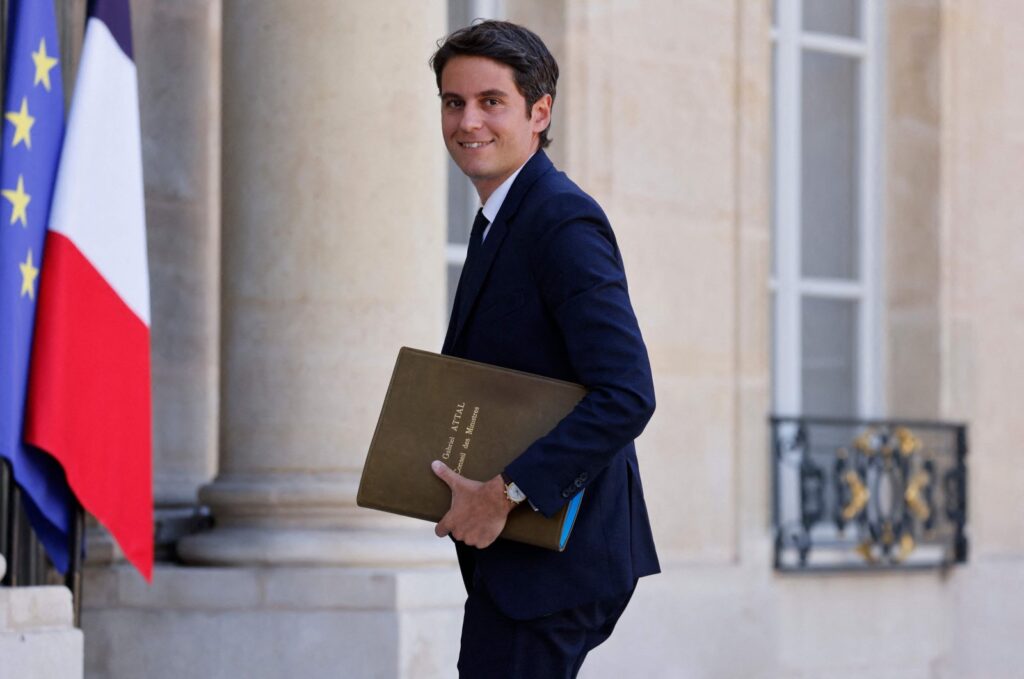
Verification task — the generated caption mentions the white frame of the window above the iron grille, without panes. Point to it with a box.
[770,0,885,418]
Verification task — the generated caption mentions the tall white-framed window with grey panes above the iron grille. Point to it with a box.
[770,0,883,417]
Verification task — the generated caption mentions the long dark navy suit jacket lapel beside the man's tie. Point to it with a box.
[444,151,553,351]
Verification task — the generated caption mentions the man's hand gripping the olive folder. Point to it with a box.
[430,460,515,549]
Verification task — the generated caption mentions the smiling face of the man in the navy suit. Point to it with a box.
[441,56,551,202]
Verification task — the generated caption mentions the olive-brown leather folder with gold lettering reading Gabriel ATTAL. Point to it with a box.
[356,347,587,551]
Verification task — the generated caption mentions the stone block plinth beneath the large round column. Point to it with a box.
[81,564,465,679]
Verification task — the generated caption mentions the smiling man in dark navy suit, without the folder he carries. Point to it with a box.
[431,22,659,679]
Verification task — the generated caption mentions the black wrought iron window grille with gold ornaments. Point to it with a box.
[771,417,968,571]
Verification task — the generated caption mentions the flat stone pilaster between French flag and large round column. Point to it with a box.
[134,0,220,510]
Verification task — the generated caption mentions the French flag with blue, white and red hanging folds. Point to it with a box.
[25,0,153,580]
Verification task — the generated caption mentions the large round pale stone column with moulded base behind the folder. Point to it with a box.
[179,0,452,565]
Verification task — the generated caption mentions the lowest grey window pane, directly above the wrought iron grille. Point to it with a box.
[801,297,858,417]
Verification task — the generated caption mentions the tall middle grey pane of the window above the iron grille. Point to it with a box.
[800,51,860,279]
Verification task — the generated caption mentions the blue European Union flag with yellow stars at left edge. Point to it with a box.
[0,0,72,572]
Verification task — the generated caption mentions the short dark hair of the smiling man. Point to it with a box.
[430,20,558,148]
